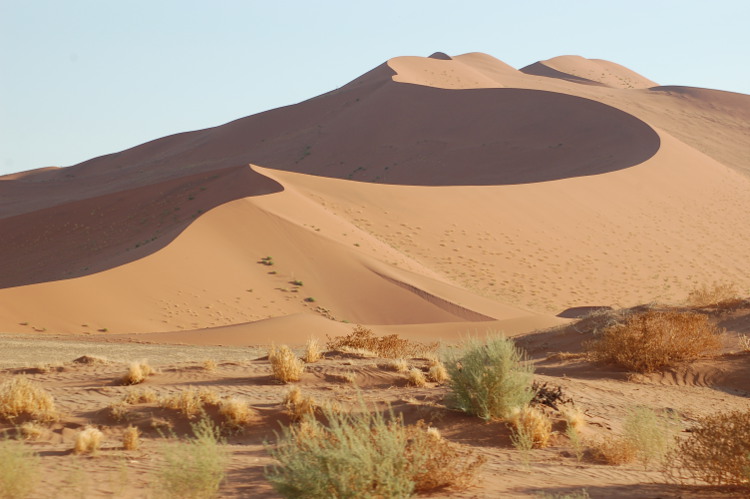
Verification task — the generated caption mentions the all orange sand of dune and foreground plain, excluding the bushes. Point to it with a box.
[0,53,750,497]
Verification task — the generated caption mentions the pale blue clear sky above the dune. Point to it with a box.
[0,0,750,175]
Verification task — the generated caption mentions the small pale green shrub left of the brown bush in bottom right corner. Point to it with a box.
[623,407,679,467]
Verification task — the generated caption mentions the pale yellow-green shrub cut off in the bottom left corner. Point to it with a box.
[0,439,39,499]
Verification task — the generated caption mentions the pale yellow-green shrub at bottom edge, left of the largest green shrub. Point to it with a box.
[155,418,229,499]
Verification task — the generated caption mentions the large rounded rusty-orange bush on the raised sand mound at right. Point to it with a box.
[585,310,721,373]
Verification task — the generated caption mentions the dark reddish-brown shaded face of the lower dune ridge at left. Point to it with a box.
[0,166,283,288]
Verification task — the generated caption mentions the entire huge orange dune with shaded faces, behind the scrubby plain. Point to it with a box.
[0,53,750,344]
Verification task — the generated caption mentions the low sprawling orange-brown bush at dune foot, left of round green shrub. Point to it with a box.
[326,326,437,359]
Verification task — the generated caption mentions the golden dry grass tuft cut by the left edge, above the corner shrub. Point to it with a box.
[0,376,58,421]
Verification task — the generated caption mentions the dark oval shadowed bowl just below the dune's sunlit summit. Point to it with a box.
[274,84,660,186]
